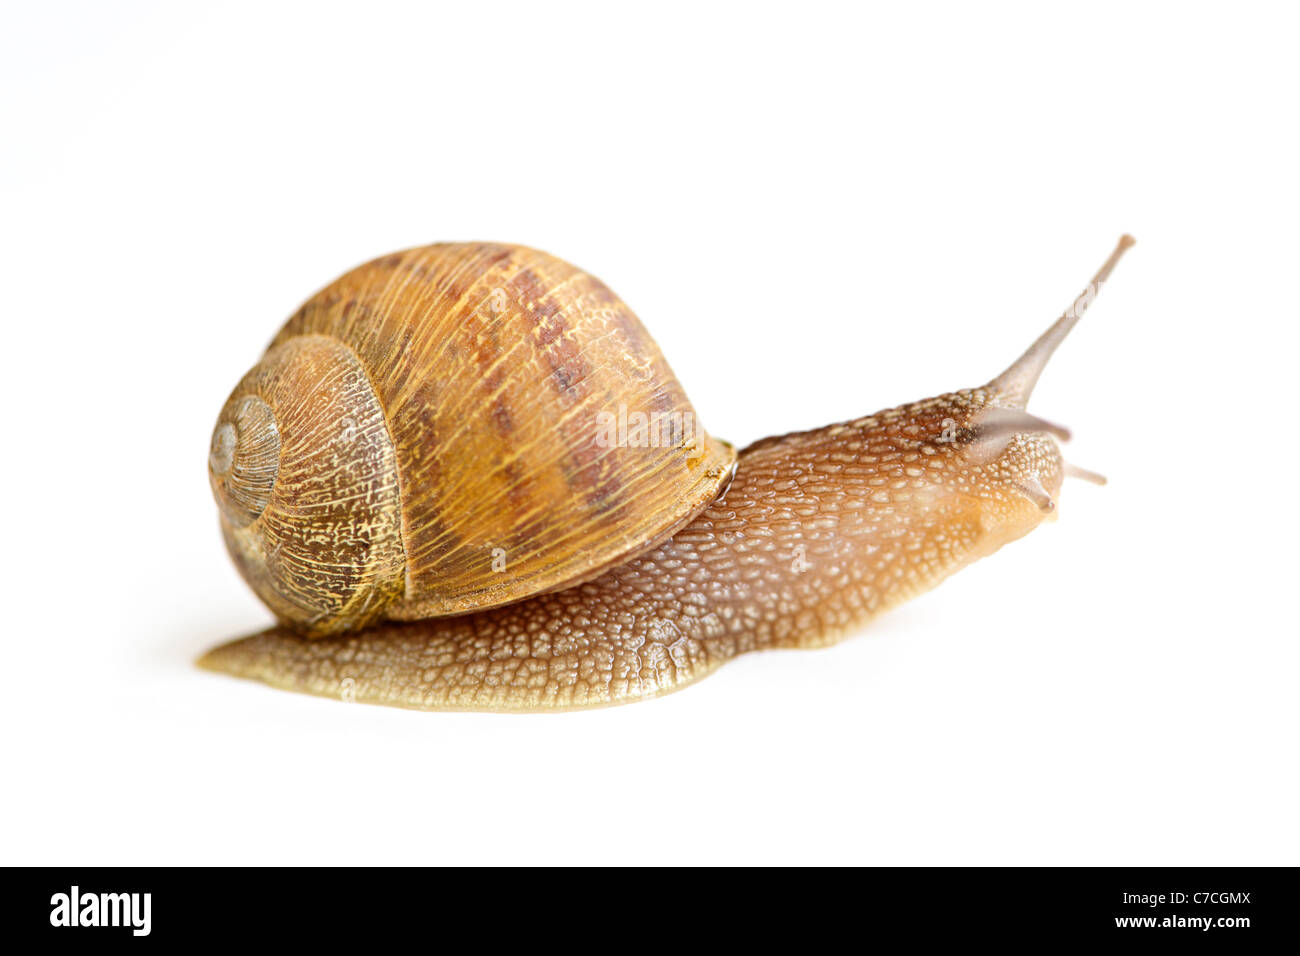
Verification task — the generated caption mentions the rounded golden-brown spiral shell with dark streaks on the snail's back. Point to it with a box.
[209,243,736,633]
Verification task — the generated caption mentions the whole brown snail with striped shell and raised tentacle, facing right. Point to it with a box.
[199,235,1134,711]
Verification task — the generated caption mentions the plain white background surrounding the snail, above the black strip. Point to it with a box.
[0,3,1300,864]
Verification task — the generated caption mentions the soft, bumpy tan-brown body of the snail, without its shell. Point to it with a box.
[202,237,1132,710]
